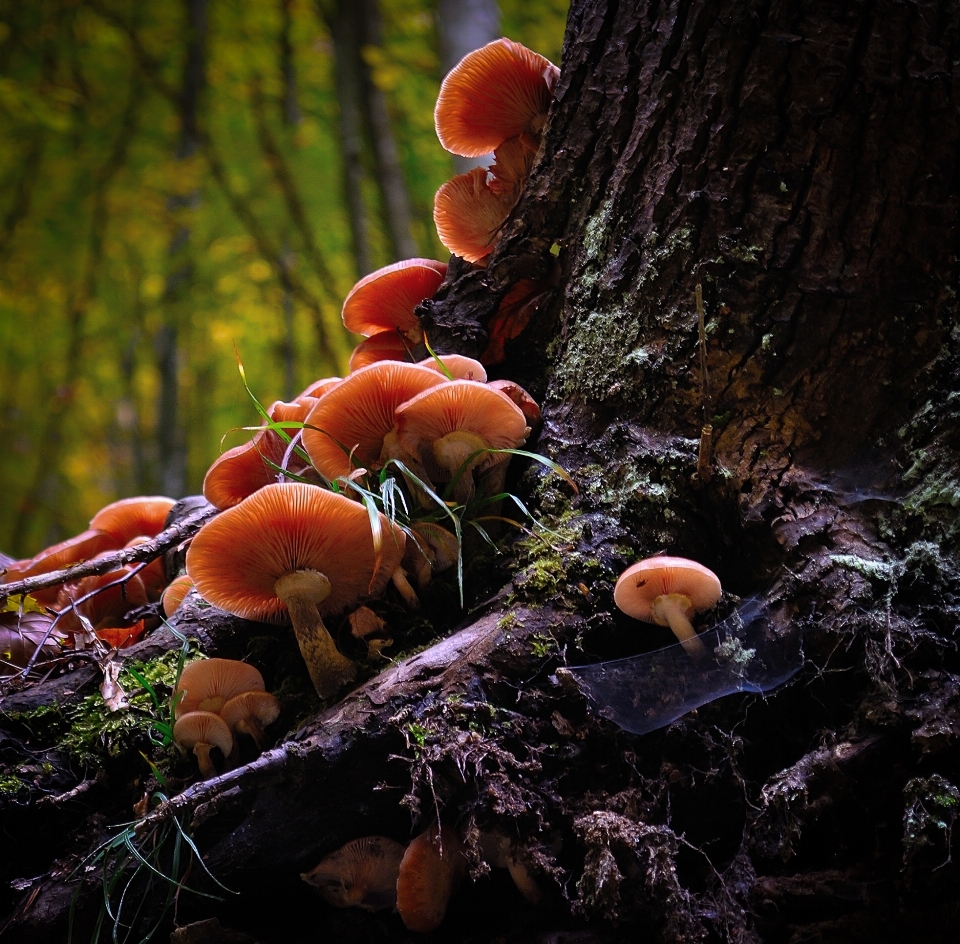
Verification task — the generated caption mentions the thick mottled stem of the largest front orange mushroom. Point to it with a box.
[273,570,357,698]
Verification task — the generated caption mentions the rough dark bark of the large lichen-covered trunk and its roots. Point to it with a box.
[5,0,960,944]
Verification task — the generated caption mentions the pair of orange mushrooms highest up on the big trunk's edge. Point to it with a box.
[433,39,560,263]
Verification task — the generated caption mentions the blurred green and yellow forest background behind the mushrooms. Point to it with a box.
[0,0,568,557]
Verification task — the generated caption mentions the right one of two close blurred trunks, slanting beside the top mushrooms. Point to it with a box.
[359,0,418,260]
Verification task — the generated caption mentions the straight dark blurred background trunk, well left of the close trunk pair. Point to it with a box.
[154,0,208,498]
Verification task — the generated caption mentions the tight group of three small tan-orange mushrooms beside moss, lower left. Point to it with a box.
[173,659,280,780]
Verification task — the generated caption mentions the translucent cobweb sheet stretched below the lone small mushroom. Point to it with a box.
[560,599,804,734]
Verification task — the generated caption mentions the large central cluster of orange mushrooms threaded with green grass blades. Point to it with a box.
[187,270,540,698]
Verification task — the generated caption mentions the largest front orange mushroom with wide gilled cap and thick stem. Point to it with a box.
[187,484,405,698]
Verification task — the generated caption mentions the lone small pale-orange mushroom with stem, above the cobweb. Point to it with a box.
[613,557,723,658]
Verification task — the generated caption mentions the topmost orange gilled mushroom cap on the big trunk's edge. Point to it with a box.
[434,39,560,157]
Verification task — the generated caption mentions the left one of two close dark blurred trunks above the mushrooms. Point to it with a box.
[328,0,373,276]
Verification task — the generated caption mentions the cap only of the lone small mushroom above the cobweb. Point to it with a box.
[613,557,723,626]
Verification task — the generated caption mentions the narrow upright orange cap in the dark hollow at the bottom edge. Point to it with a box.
[397,826,466,932]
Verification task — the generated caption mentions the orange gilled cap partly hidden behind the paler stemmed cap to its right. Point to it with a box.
[303,361,444,480]
